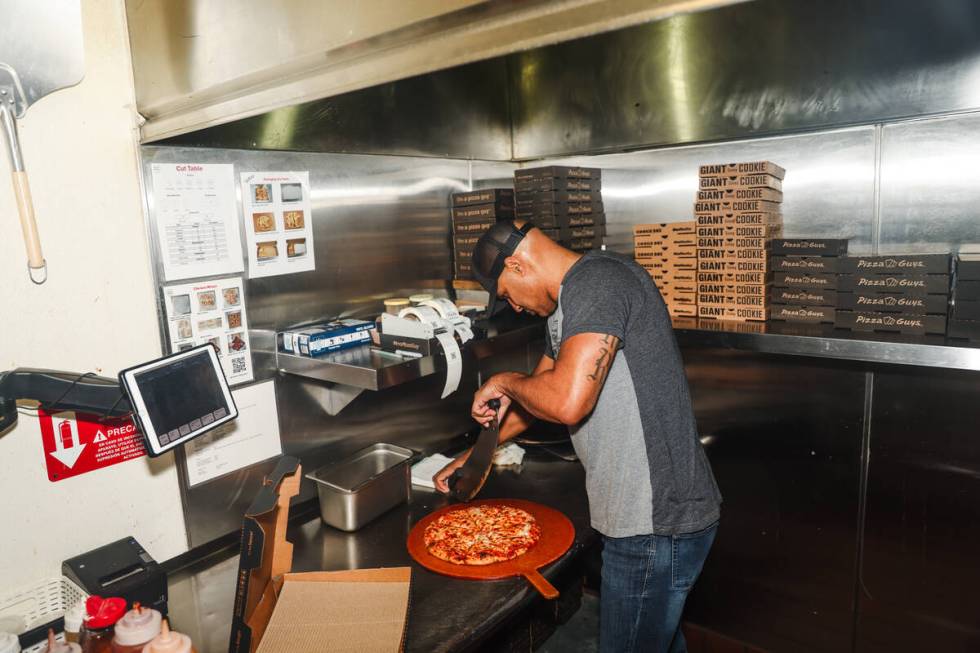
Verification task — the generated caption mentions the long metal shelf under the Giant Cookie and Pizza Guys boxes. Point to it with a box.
[674,318,980,371]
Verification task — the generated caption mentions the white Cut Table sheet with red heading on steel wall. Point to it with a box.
[150,163,244,281]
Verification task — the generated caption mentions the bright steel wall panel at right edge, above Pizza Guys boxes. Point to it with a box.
[880,111,980,253]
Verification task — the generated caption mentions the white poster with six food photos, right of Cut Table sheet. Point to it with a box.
[241,172,316,279]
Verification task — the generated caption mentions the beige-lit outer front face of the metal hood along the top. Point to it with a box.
[126,0,743,142]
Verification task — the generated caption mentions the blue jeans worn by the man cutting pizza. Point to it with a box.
[599,523,718,653]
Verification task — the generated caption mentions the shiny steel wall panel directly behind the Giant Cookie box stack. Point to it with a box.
[540,127,875,253]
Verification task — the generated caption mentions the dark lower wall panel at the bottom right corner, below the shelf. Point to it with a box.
[856,369,980,653]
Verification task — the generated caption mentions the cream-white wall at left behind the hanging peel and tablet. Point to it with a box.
[0,0,186,598]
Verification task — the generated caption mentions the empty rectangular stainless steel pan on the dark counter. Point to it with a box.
[306,442,415,531]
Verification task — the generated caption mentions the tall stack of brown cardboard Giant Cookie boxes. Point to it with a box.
[694,161,786,321]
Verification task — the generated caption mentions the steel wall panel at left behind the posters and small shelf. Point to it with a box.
[142,146,526,546]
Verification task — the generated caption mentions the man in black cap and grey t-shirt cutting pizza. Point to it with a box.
[434,221,721,653]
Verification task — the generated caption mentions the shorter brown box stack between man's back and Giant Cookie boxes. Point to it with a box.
[633,220,698,317]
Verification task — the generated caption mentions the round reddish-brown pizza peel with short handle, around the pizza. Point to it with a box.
[408,499,575,599]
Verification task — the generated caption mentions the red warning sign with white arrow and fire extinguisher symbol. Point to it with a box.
[38,410,146,482]
